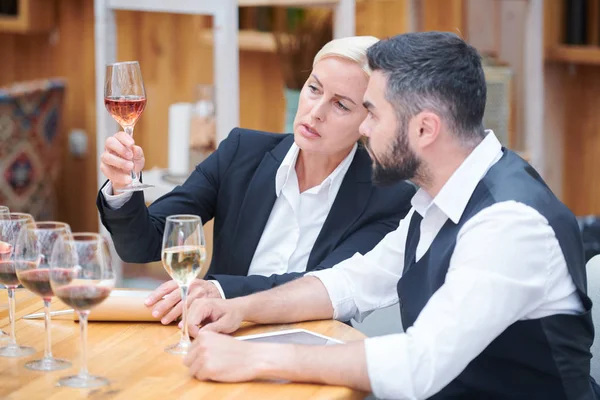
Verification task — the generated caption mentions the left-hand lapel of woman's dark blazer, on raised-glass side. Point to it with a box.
[224,135,294,275]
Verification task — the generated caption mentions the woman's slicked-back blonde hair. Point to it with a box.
[313,36,379,76]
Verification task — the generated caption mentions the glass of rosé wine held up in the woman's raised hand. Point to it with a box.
[104,61,153,192]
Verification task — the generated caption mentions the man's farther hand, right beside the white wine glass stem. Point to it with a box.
[186,299,244,337]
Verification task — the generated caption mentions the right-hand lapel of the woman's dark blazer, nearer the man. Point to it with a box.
[306,145,371,271]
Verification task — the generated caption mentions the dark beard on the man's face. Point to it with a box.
[366,124,422,186]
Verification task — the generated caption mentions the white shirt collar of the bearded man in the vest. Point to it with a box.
[411,130,502,224]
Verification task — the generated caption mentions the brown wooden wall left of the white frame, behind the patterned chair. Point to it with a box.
[0,0,98,231]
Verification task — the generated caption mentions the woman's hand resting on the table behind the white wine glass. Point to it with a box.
[145,279,221,325]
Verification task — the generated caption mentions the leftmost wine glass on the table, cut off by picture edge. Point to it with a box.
[0,213,35,357]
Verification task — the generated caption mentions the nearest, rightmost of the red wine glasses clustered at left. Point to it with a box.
[50,233,115,388]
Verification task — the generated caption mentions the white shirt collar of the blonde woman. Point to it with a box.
[275,143,358,201]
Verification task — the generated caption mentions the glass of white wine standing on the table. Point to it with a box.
[162,215,206,354]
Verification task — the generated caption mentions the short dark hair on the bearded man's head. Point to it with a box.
[367,32,487,142]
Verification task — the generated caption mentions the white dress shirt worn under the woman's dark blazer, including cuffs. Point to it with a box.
[102,143,358,298]
